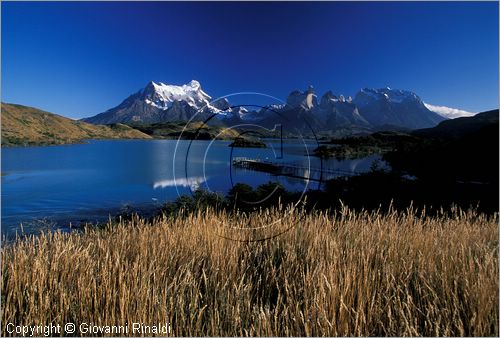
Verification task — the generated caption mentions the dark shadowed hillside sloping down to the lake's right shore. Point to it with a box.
[386,109,499,185]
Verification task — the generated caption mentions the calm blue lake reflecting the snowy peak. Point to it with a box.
[1,140,379,235]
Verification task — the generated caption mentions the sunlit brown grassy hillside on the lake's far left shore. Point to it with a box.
[1,103,151,146]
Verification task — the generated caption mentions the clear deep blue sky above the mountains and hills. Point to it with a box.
[2,2,499,118]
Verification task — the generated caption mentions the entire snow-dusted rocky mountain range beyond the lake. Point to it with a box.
[83,80,447,131]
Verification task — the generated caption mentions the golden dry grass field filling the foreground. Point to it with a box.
[1,208,499,336]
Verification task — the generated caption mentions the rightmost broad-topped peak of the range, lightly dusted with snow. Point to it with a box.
[353,87,446,129]
